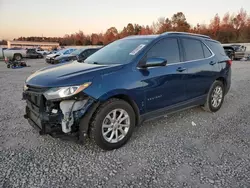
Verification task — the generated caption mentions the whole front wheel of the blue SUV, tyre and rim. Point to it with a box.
[90,98,135,150]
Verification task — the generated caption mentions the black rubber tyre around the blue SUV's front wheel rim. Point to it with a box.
[89,98,135,150]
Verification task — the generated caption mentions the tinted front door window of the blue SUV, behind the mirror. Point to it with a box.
[147,38,180,64]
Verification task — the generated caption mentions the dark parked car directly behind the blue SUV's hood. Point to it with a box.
[52,47,100,64]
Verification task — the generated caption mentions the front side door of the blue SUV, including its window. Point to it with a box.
[140,38,187,112]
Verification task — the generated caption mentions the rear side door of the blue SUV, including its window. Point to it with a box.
[181,38,218,99]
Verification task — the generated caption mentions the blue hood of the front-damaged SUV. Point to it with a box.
[25,61,123,87]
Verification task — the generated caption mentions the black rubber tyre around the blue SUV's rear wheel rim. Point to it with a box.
[203,80,225,112]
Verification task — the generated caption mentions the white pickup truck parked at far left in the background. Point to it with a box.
[3,48,27,61]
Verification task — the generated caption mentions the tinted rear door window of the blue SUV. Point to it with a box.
[182,39,204,61]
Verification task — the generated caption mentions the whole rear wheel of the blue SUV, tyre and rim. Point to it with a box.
[202,80,225,112]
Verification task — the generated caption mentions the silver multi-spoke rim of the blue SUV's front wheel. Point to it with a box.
[102,109,130,143]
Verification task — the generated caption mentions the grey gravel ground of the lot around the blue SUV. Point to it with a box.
[0,59,250,188]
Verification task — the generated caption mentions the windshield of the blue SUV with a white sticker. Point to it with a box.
[84,38,153,64]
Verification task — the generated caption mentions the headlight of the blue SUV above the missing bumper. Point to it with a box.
[44,82,91,100]
